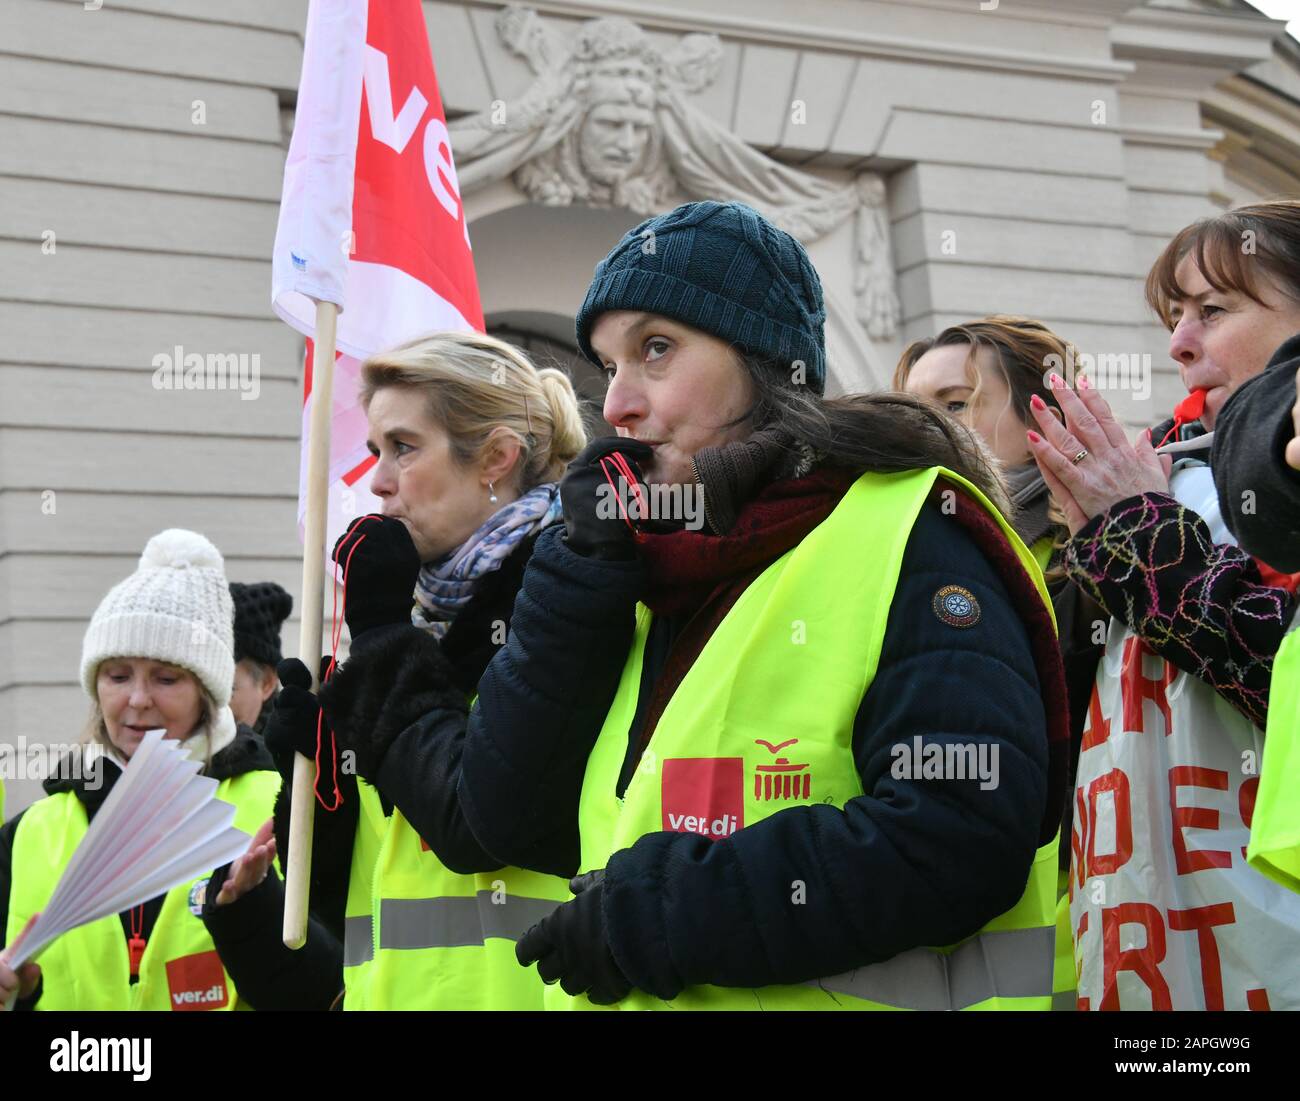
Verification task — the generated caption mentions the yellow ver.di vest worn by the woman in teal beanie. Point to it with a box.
[559,468,1057,1010]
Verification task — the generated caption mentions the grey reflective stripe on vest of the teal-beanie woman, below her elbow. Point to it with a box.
[807,926,1056,1010]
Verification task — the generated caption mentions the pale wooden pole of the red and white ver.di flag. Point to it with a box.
[283,302,338,948]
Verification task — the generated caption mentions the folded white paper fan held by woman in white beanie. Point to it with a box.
[0,731,251,1008]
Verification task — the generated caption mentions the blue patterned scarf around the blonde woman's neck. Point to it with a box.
[411,482,560,640]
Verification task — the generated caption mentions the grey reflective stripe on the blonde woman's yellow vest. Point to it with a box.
[380,890,560,949]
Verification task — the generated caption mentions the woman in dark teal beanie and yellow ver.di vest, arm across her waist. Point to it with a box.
[410,203,1067,1009]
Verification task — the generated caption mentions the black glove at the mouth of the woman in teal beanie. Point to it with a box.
[560,435,654,559]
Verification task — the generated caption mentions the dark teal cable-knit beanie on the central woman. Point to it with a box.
[577,201,826,394]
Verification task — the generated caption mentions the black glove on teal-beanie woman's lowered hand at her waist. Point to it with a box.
[515,868,632,1005]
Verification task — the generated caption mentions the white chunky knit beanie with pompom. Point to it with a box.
[81,528,235,753]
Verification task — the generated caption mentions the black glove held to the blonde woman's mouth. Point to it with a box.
[334,513,420,640]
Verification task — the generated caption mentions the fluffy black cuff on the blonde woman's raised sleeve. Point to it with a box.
[321,624,469,784]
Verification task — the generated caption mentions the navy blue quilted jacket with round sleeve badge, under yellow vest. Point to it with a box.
[369,488,1067,989]
